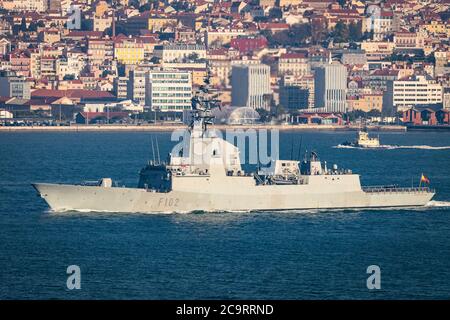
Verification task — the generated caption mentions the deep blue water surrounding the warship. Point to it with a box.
[0,131,450,299]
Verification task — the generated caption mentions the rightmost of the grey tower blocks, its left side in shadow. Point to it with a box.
[314,63,347,112]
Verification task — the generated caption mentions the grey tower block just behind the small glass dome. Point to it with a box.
[231,64,272,110]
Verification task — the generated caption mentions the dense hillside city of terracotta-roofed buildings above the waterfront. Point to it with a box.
[0,0,450,126]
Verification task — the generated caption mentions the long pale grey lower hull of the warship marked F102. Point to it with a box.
[33,182,434,213]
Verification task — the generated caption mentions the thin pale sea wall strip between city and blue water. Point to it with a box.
[0,124,407,132]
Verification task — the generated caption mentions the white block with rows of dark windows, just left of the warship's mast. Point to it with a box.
[145,70,192,112]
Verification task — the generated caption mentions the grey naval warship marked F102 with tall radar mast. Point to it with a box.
[33,79,435,213]
